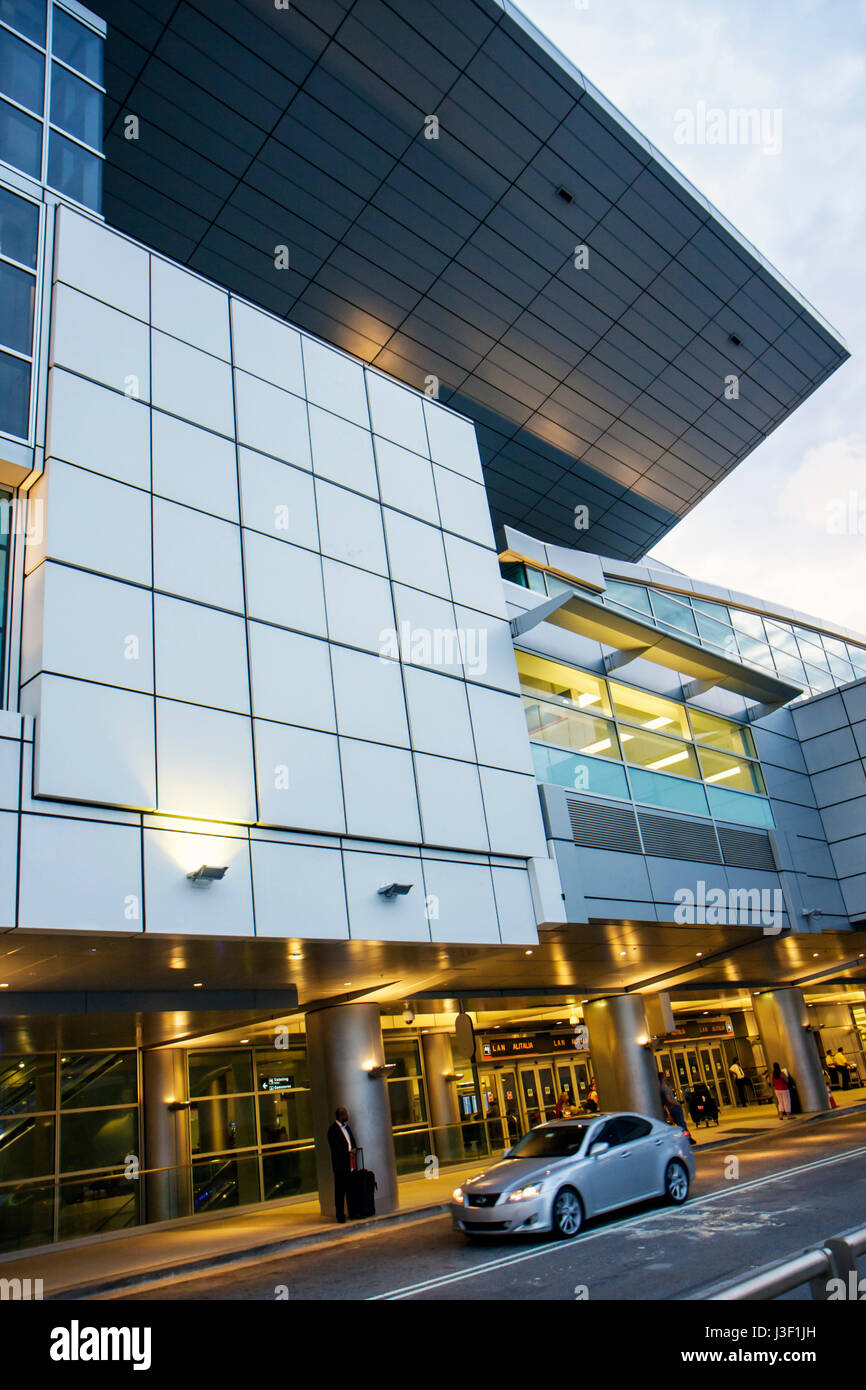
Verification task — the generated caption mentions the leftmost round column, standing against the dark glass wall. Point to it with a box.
[142,1048,192,1222]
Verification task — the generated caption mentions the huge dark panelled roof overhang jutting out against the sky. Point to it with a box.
[92,0,848,559]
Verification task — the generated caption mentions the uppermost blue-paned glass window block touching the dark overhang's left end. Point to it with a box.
[0,0,104,211]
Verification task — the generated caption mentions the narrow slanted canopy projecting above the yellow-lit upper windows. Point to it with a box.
[512,581,802,719]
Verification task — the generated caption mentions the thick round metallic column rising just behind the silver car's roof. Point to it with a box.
[584,994,662,1119]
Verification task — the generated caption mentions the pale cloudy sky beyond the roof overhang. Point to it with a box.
[518,0,866,634]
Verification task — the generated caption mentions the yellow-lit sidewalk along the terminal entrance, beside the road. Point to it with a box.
[0,1091,866,1298]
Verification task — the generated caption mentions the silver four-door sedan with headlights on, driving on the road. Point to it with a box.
[450,1113,695,1240]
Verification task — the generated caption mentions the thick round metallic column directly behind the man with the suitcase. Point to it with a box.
[306,1004,399,1218]
